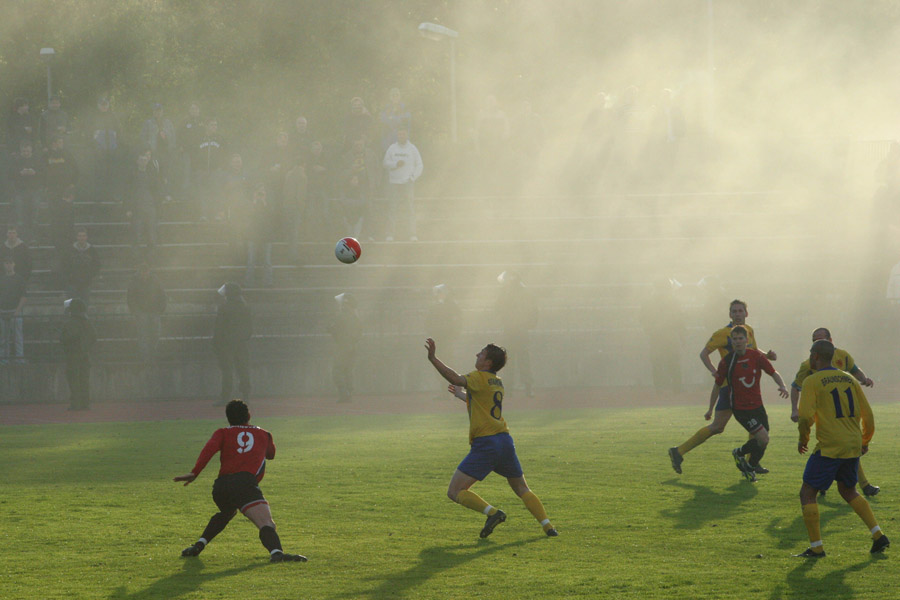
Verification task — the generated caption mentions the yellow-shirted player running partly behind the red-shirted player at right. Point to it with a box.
[669,300,778,473]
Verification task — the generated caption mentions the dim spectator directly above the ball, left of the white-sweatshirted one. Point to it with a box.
[337,138,381,237]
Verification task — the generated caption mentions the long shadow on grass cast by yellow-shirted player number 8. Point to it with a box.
[333,534,546,600]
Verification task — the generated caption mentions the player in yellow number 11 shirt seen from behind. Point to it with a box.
[795,340,891,558]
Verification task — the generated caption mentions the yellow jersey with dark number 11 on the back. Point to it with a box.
[797,367,875,458]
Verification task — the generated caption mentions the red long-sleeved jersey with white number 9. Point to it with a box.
[191,425,275,482]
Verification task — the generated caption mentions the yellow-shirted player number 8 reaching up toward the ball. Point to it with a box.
[425,338,559,538]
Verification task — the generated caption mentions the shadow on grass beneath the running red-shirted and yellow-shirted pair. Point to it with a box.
[659,479,758,529]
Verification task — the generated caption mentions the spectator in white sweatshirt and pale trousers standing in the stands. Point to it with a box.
[383,127,422,242]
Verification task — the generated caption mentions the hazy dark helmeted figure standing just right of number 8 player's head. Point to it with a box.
[496,271,538,396]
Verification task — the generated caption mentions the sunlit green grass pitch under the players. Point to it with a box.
[0,404,900,600]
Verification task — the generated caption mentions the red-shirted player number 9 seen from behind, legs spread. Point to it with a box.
[174,400,306,562]
